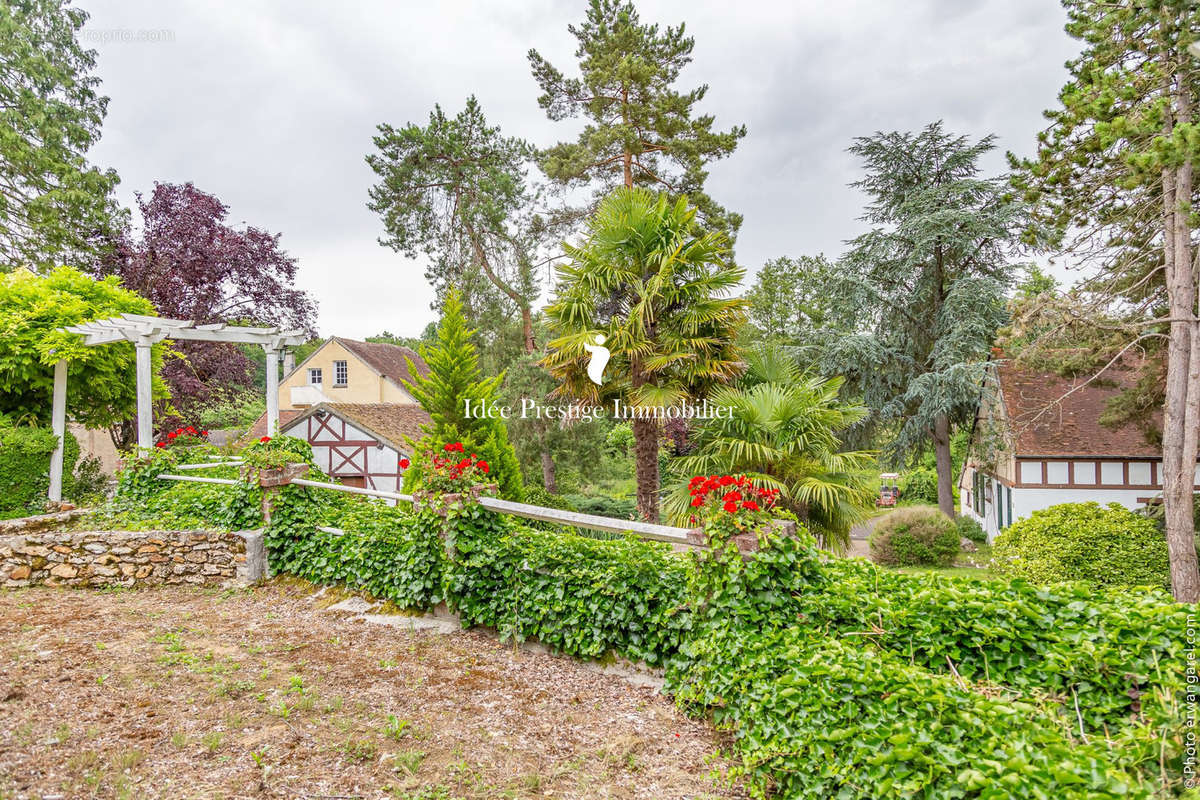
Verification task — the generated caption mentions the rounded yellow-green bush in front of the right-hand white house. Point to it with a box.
[992,503,1170,587]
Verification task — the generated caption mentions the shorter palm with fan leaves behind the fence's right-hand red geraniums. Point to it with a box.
[666,347,875,549]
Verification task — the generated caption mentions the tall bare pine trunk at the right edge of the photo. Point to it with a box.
[1163,134,1200,603]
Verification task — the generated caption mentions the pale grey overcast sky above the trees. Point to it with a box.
[76,0,1078,338]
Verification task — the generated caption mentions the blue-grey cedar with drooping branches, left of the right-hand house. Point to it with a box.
[822,122,1025,516]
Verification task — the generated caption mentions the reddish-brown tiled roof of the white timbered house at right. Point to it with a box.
[997,361,1163,458]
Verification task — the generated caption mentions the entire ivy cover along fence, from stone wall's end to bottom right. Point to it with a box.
[105,448,1186,800]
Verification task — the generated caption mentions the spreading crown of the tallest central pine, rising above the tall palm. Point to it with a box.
[529,0,746,241]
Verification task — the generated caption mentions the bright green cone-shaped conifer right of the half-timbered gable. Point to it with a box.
[404,290,524,500]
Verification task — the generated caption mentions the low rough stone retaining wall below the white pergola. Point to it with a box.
[0,529,262,587]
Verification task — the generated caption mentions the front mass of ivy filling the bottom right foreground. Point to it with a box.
[668,627,1152,800]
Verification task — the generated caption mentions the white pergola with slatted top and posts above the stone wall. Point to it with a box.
[49,314,305,501]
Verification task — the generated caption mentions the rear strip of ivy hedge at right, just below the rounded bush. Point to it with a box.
[797,559,1187,730]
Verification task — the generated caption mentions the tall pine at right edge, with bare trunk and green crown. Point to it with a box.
[1012,0,1200,602]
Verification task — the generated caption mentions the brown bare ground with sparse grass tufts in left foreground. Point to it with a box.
[0,585,743,800]
